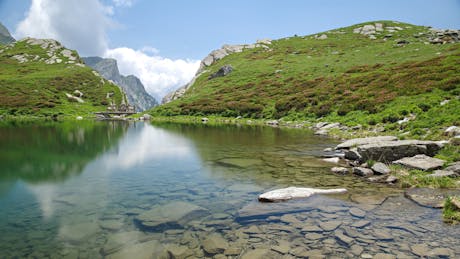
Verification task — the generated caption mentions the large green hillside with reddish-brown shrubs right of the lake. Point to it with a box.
[151,21,460,139]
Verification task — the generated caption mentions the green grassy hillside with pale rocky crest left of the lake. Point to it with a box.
[0,38,122,117]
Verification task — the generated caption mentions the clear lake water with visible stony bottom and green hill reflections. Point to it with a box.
[0,122,460,258]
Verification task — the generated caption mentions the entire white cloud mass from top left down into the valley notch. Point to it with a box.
[14,0,199,100]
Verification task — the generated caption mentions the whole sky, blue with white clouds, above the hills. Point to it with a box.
[0,0,460,98]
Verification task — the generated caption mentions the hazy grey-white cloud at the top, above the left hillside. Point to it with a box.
[14,0,113,55]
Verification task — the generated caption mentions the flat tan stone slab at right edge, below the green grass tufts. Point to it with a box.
[404,188,460,208]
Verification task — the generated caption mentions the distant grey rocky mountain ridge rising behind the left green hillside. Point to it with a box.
[83,57,158,111]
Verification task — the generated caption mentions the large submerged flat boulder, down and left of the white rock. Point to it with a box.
[135,201,209,230]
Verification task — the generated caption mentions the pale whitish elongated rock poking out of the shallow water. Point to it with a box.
[259,187,347,202]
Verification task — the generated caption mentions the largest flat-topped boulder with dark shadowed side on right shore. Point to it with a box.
[357,140,444,162]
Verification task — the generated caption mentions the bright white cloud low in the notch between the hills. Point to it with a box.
[105,47,200,100]
